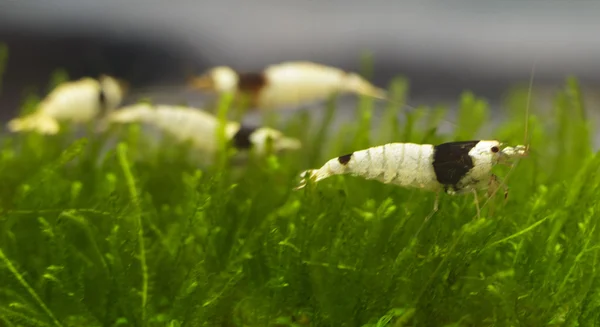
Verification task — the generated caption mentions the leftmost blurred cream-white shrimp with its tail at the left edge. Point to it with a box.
[7,75,128,134]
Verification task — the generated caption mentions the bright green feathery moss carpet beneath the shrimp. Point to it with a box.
[0,72,600,327]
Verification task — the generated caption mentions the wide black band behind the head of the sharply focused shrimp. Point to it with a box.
[433,141,479,191]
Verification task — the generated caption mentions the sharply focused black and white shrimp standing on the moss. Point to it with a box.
[296,140,528,218]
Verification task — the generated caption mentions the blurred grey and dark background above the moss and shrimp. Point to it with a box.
[0,0,600,141]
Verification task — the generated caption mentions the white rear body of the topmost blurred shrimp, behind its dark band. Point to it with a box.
[257,62,385,109]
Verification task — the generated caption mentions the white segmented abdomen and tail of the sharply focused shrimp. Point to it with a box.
[299,143,441,191]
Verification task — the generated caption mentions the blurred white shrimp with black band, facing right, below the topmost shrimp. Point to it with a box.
[108,103,301,154]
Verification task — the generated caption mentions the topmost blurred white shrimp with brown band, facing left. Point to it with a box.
[189,61,386,110]
